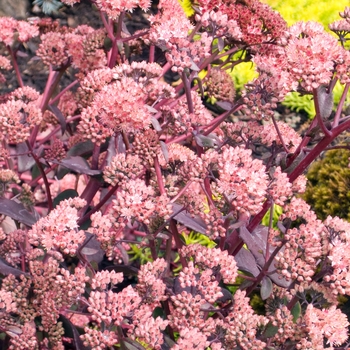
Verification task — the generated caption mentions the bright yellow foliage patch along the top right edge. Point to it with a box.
[262,0,350,28]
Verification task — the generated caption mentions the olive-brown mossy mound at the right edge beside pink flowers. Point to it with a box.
[303,149,350,221]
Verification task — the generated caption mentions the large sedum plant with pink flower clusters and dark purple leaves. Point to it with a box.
[0,0,350,350]
